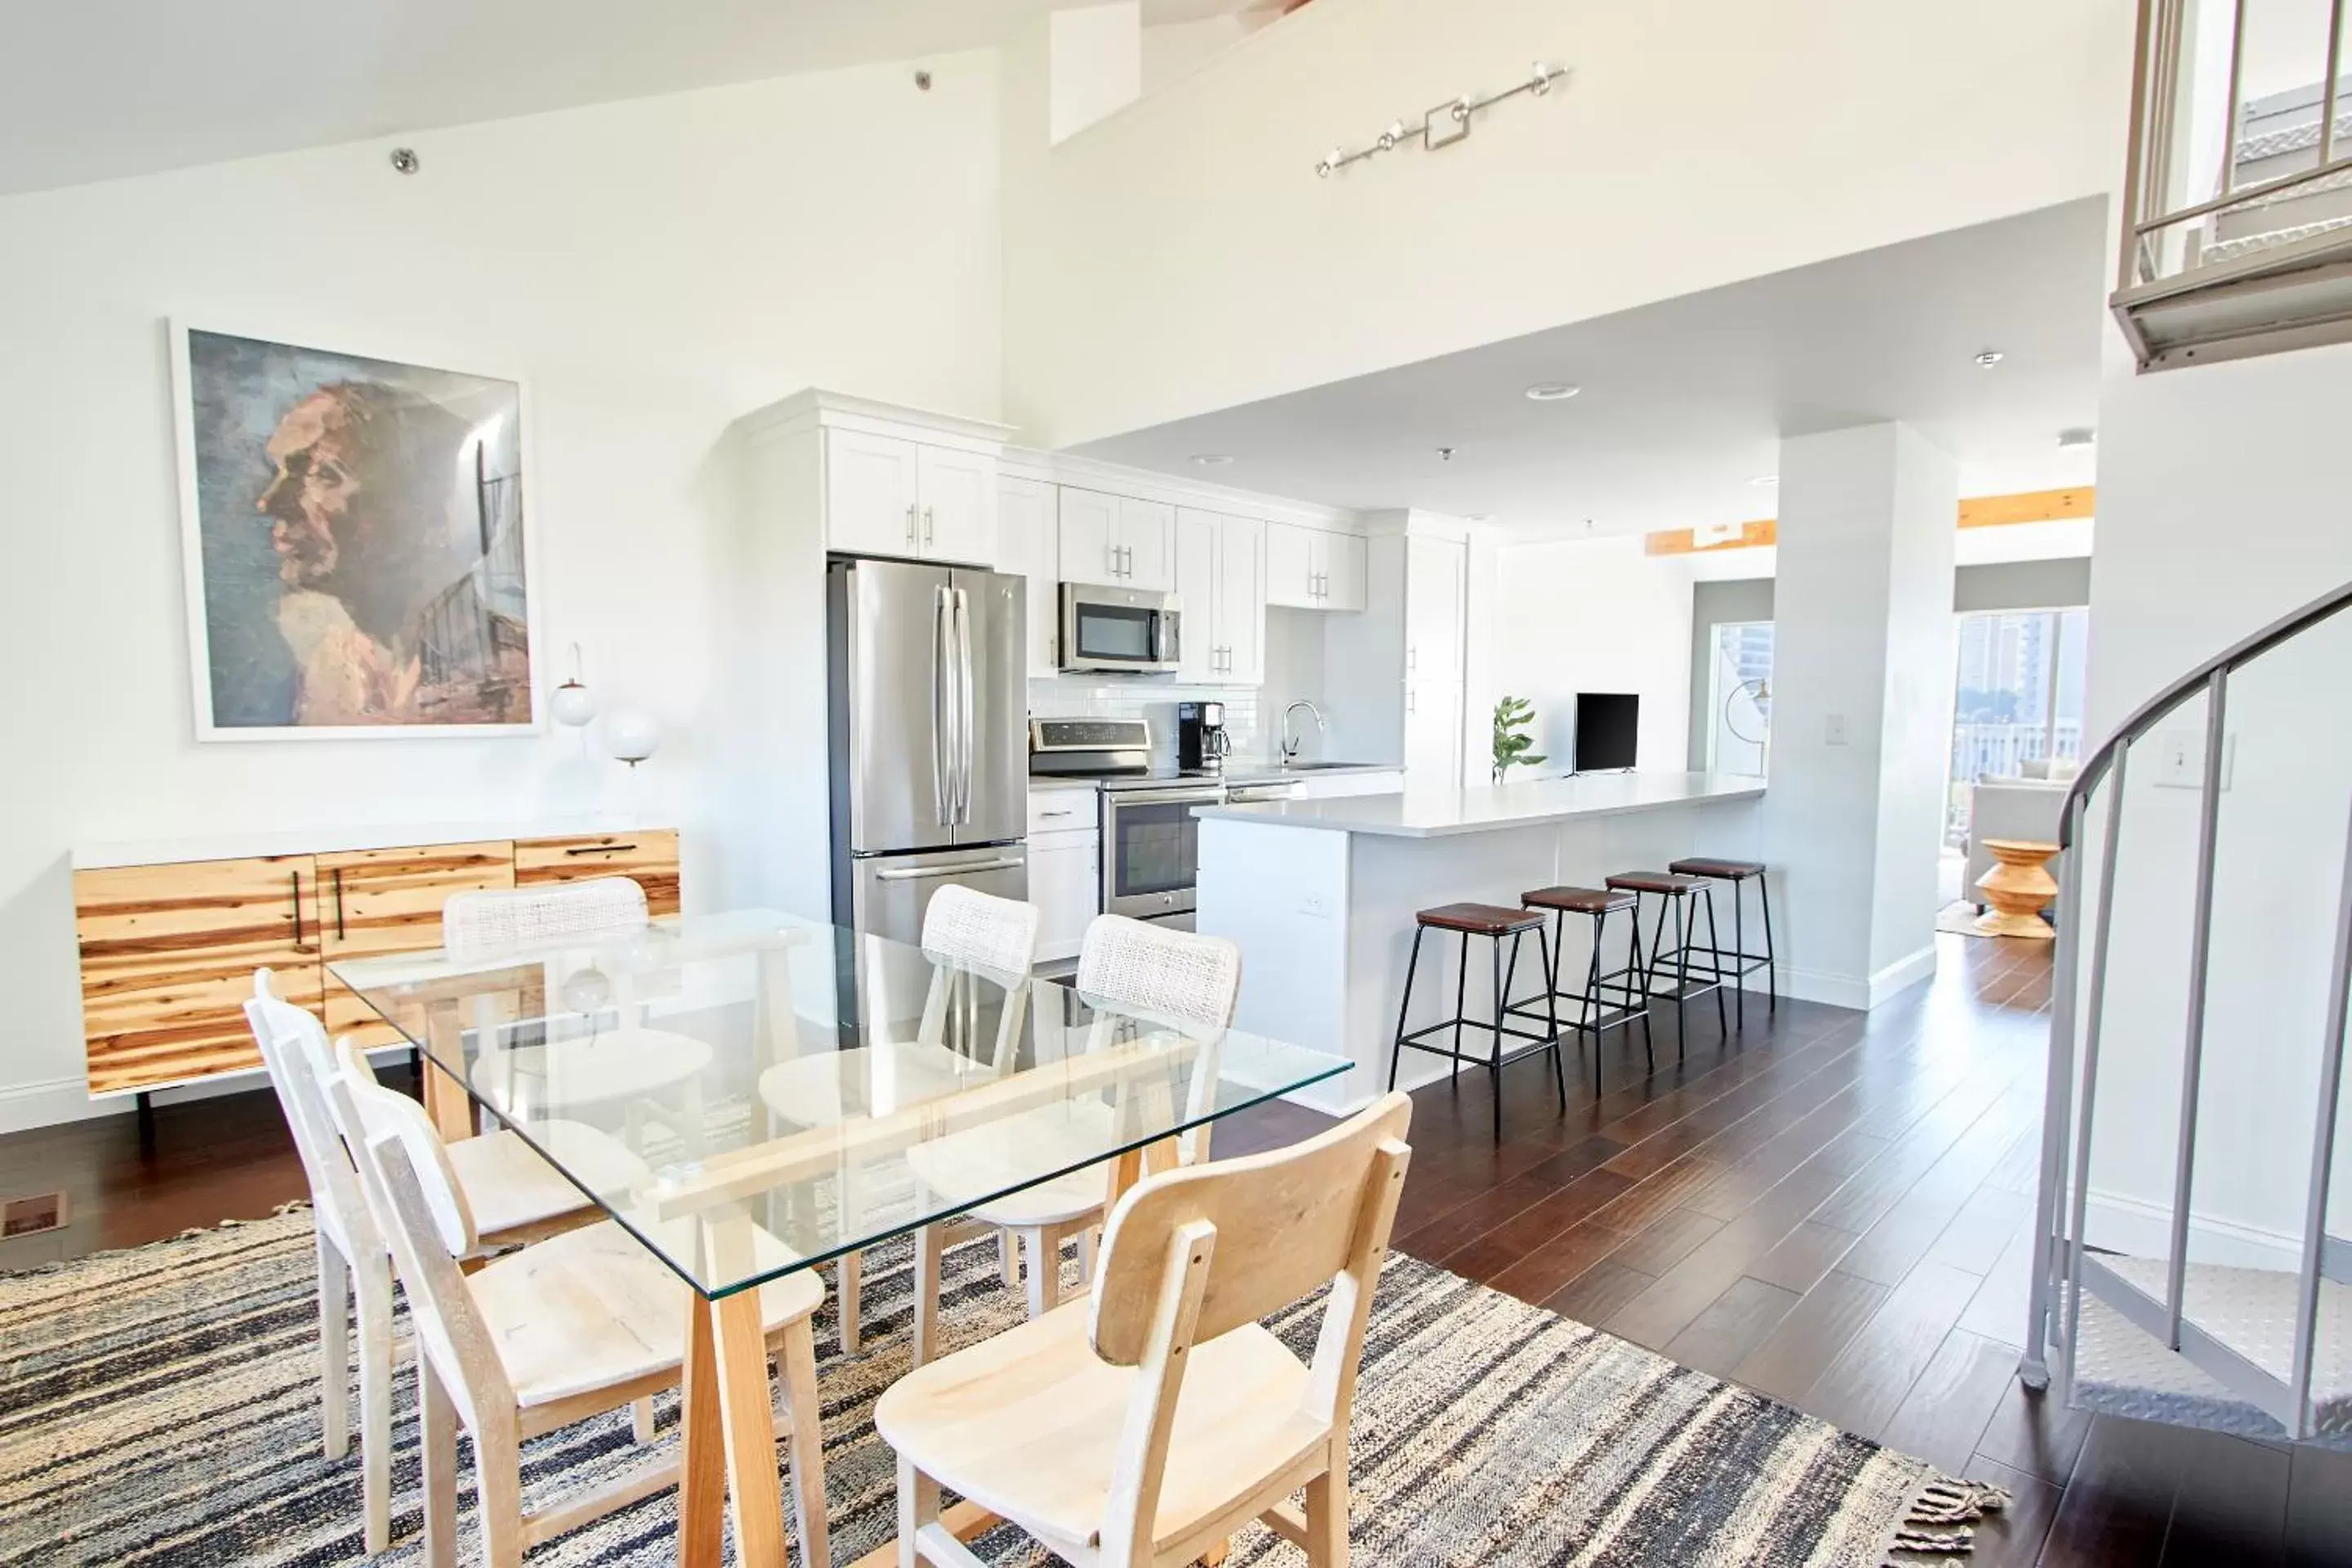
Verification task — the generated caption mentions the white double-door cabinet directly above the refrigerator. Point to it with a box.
[826,430,997,564]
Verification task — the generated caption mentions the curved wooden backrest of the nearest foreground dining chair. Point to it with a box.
[1091,1094,1414,1365]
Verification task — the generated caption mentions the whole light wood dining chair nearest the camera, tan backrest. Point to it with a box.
[875,1094,1414,1568]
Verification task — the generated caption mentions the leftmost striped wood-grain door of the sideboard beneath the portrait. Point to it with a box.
[73,856,323,1095]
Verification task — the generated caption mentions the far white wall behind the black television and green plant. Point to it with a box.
[1470,536,1691,778]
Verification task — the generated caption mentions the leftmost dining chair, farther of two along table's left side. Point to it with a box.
[245,969,652,1552]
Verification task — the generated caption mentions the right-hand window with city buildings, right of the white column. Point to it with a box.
[1945,609,2091,849]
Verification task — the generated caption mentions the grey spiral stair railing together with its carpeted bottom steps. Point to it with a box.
[2020,583,2352,1446]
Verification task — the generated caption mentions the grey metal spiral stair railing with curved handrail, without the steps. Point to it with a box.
[2018,583,2352,1439]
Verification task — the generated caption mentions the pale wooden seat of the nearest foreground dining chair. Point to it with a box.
[875,1297,1331,1561]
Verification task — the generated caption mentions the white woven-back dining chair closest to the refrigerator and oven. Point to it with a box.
[760,884,1040,1354]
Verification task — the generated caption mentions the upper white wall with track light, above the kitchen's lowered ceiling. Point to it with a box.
[1004,0,2133,447]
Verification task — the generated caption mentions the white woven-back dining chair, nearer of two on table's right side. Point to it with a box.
[908,915,1242,1349]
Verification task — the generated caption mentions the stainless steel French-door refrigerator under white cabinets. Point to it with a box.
[826,559,1028,942]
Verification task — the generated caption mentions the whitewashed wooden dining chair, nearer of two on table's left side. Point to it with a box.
[334,1039,833,1568]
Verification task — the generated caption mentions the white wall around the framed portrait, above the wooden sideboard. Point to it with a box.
[0,54,1000,1129]
